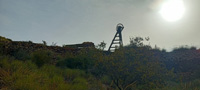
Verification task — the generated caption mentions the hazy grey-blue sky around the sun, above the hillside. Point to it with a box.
[0,0,200,50]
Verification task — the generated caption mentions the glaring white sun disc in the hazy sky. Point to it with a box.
[159,0,185,22]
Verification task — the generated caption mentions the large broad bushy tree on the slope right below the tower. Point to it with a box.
[96,38,166,90]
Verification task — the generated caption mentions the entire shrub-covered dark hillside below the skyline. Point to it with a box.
[0,37,200,90]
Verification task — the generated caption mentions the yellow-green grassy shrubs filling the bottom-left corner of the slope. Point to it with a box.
[0,58,78,90]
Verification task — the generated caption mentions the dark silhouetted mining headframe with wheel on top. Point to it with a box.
[108,23,124,52]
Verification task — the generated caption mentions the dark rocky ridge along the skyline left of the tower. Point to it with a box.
[0,36,94,55]
